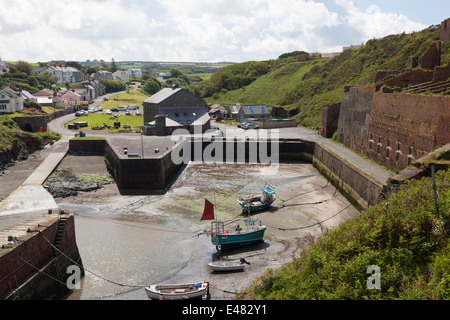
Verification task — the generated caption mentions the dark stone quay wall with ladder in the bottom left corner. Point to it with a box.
[0,211,83,300]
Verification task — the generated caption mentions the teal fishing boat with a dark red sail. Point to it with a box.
[201,199,267,251]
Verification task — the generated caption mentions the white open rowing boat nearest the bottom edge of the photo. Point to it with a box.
[144,281,209,300]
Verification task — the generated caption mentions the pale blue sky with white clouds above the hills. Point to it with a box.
[0,0,450,63]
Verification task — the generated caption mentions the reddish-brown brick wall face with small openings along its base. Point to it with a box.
[358,93,450,170]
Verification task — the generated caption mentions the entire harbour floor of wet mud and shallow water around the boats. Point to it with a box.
[51,156,357,300]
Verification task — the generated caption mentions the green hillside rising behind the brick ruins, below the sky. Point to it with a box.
[199,28,450,129]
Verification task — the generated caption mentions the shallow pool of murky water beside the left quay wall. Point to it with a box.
[59,206,206,300]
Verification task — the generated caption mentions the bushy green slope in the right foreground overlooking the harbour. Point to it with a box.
[238,171,450,300]
